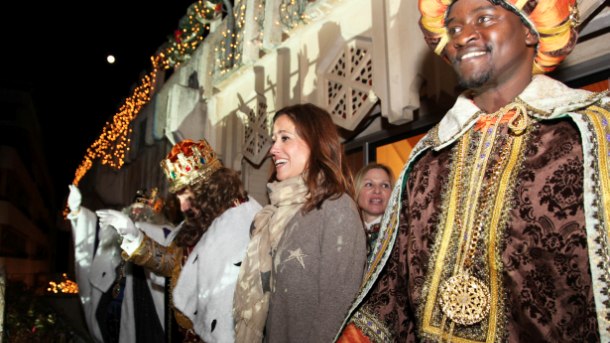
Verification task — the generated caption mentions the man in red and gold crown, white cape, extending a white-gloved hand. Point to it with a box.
[98,140,261,343]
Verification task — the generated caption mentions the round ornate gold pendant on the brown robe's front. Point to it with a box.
[439,274,490,325]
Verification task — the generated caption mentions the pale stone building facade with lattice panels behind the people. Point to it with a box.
[88,0,610,210]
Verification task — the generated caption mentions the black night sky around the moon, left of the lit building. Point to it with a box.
[0,0,194,207]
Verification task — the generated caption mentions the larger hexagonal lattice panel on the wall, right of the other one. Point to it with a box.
[320,39,376,130]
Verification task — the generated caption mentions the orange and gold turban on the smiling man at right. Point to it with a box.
[418,0,578,74]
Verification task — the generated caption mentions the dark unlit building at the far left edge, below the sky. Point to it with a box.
[0,89,56,286]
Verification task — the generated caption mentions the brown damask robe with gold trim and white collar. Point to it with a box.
[339,76,610,342]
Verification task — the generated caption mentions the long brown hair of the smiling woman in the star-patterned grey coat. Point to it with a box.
[273,104,354,213]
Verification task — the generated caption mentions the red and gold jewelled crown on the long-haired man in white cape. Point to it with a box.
[161,139,222,193]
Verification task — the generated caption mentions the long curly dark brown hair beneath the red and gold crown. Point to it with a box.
[175,167,248,247]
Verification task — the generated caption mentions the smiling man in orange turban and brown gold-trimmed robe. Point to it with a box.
[338,0,610,342]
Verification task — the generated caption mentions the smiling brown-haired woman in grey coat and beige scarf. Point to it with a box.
[234,104,366,343]
